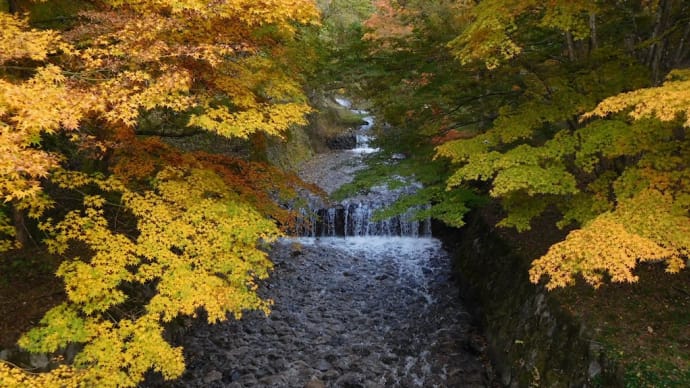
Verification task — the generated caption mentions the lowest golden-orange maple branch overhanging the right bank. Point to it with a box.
[530,190,690,289]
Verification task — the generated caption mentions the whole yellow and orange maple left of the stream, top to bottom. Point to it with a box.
[0,0,318,386]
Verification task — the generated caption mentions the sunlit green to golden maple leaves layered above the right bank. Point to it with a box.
[430,0,690,288]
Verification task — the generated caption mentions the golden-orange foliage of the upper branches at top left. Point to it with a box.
[0,0,318,245]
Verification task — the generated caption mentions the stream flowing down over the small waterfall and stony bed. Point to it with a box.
[154,99,492,388]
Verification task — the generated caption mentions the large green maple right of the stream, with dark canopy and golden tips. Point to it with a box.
[354,0,690,288]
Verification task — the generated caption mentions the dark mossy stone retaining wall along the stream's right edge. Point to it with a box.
[434,212,621,387]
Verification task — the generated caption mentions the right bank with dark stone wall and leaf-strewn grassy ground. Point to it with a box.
[434,209,690,387]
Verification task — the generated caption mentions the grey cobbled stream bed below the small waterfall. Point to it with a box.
[141,232,490,388]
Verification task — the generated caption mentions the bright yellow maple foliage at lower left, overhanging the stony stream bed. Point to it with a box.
[6,167,278,387]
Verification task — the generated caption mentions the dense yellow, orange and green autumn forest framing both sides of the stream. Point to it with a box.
[0,0,690,386]
